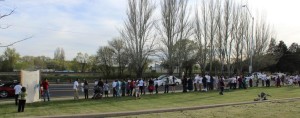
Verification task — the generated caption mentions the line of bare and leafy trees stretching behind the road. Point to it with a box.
[0,0,300,78]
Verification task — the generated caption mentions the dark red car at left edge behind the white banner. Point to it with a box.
[0,82,17,98]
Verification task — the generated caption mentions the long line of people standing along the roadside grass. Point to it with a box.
[68,74,300,99]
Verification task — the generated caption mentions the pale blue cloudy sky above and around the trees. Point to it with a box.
[0,0,300,60]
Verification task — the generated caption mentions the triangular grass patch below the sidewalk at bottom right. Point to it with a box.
[119,100,300,118]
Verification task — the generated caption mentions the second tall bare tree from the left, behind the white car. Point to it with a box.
[157,0,191,74]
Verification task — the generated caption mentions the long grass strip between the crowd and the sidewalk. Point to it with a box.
[0,87,300,117]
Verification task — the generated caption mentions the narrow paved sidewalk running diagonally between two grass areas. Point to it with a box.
[39,97,300,118]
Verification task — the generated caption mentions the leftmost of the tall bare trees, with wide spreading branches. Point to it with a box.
[121,0,155,78]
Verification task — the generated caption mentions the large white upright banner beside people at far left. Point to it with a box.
[21,70,40,103]
